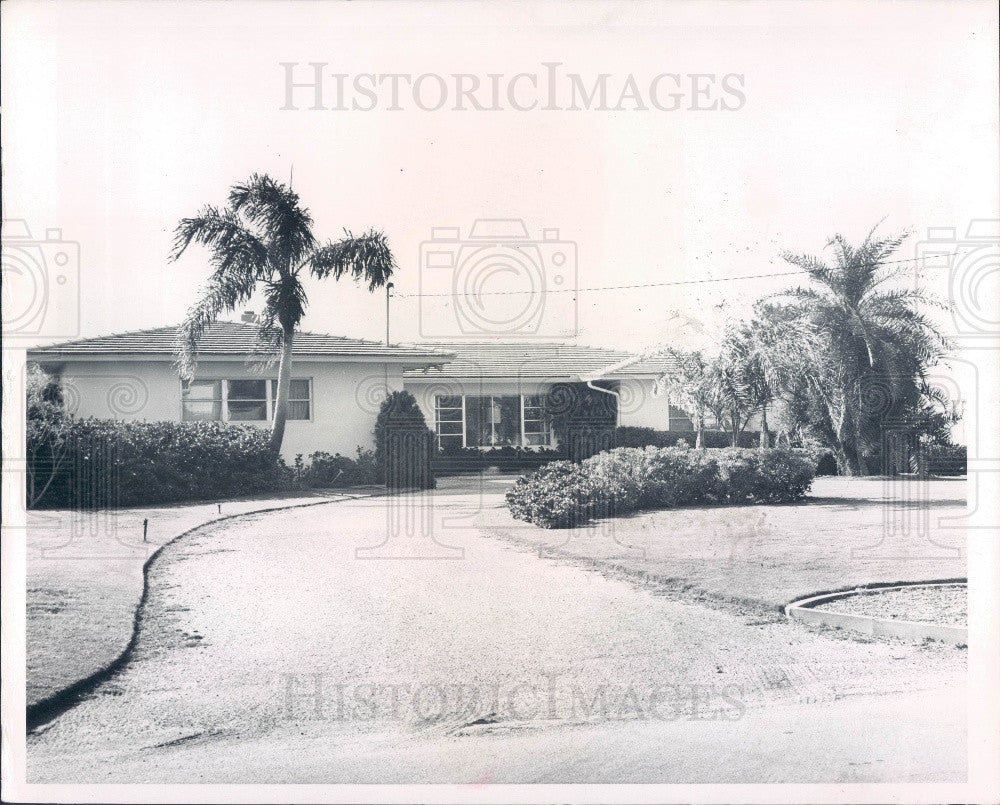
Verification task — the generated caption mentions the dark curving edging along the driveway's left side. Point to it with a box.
[25,493,380,734]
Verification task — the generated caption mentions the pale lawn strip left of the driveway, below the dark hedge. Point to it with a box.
[26,488,374,706]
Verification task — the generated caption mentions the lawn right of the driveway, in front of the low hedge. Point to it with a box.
[479,477,967,610]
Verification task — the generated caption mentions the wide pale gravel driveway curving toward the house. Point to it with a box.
[28,490,965,783]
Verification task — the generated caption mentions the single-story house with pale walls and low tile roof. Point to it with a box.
[28,322,691,460]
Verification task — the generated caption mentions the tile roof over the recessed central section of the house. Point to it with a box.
[406,342,680,380]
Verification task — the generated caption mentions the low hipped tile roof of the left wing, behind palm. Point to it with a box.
[28,322,452,359]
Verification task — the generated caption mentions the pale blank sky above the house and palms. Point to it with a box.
[2,0,1000,358]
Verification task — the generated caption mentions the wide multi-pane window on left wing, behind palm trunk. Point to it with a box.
[181,379,312,422]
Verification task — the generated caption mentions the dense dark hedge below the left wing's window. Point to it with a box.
[27,417,293,508]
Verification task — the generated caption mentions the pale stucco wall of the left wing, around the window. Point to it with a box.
[36,359,406,461]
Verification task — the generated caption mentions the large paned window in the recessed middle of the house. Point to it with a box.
[434,394,550,450]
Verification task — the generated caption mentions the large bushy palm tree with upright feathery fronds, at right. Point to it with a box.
[777,227,949,475]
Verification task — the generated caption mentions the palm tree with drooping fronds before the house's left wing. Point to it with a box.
[170,173,396,454]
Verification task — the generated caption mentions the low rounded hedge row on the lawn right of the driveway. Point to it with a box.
[506,447,816,528]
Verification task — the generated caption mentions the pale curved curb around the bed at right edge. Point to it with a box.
[785,579,969,645]
